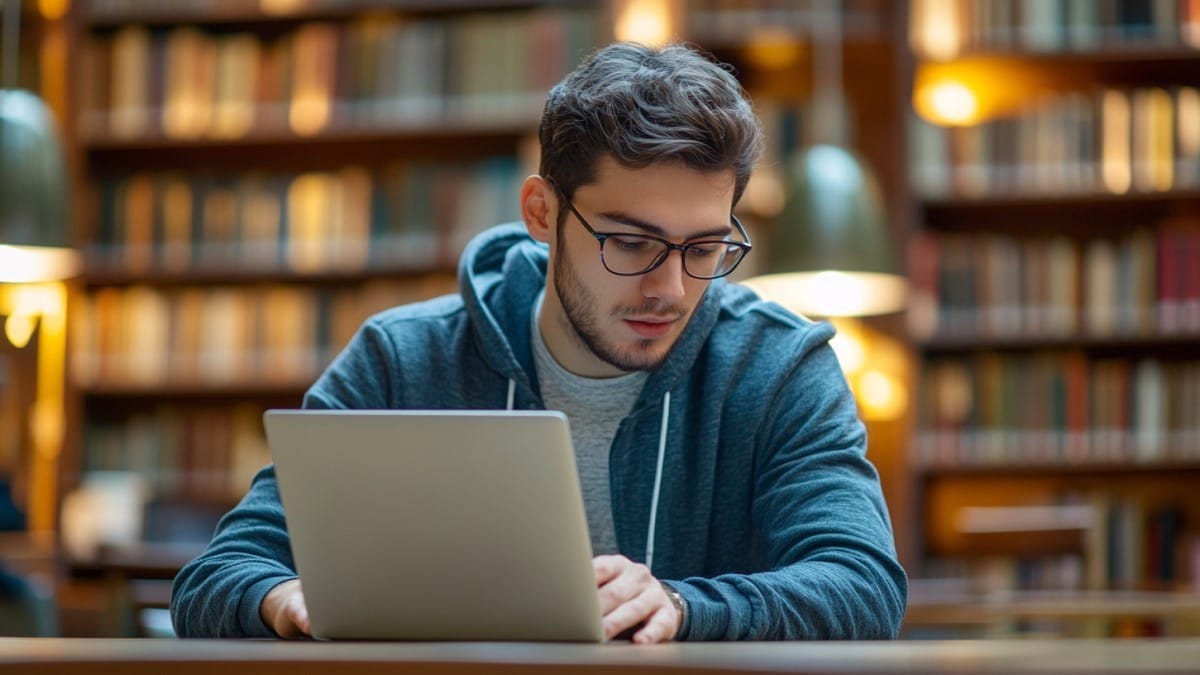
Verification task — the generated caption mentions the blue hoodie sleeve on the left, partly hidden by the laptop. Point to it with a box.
[170,322,390,638]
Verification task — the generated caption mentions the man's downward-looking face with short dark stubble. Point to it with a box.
[540,157,736,377]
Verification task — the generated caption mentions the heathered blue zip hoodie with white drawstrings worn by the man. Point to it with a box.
[170,225,907,640]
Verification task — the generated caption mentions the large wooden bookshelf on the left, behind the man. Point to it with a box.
[62,0,607,571]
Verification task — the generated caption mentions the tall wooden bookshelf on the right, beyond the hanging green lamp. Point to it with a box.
[907,0,1200,634]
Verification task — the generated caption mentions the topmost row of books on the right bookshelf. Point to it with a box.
[910,0,1200,59]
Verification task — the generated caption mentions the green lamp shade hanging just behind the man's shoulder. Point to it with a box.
[746,144,907,316]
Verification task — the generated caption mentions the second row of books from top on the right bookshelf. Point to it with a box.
[910,85,1200,197]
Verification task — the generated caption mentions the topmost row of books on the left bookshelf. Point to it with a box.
[80,8,598,139]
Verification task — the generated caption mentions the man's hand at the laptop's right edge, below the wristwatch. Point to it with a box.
[592,555,679,645]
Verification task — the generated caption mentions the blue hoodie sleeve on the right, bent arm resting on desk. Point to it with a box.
[674,345,907,640]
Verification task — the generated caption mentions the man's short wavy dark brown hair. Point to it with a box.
[539,42,762,217]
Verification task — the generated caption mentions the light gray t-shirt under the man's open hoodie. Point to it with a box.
[532,292,647,555]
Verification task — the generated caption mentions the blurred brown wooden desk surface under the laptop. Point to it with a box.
[0,638,1200,675]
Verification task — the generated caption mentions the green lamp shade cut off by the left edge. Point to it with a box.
[0,89,78,282]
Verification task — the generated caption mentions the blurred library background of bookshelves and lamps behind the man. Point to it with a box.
[0,0,1200,653]
